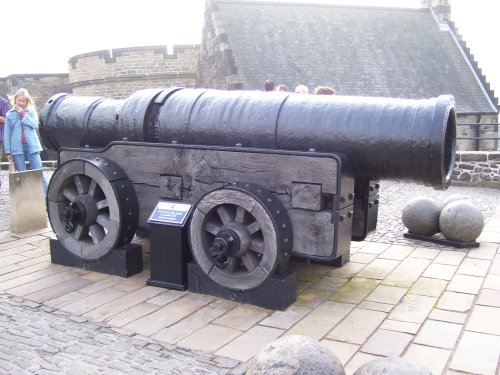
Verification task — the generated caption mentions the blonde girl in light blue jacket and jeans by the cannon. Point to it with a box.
[4,89,48,195]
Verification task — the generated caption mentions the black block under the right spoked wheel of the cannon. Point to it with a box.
[188,262,297,310]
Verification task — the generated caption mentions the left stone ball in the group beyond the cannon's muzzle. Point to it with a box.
[401,197,441,236]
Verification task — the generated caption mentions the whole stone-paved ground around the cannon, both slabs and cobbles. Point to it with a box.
[0,176,500,375]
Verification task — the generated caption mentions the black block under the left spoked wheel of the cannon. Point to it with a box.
[50,239,143,277]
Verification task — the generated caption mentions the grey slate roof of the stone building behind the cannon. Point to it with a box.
[207,0,497,113]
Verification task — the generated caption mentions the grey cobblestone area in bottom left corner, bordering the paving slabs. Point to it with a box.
[0,293,242,375]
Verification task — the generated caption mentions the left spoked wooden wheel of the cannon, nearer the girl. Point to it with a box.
[48,157,139,260]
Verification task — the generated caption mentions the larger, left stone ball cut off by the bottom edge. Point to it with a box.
[245,335,345,375]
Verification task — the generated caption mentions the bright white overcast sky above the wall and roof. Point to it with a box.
[0,0,500,97]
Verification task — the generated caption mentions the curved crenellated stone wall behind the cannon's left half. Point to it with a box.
[69,45,200,99]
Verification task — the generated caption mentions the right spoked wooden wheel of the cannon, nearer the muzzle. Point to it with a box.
[189,183,293,291]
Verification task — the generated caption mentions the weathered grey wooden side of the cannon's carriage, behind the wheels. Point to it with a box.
[60,144,353,257]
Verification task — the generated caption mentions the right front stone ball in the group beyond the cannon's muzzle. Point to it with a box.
[439,200,484,242]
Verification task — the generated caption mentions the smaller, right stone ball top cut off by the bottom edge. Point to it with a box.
[353,357,432,375]
